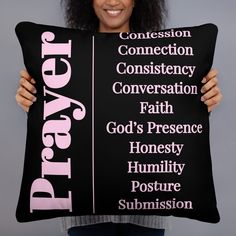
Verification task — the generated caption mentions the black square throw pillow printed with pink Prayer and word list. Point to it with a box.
[16,22,219,223]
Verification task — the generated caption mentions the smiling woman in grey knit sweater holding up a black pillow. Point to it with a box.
[16,0,222,236]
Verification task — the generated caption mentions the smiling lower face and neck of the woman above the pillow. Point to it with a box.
[93,0,134,32]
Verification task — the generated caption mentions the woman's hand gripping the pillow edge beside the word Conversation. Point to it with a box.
[201,69,222,112]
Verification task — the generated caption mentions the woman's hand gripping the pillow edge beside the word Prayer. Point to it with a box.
[15,70,36,112]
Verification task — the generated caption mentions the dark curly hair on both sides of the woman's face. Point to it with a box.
[62,0,167,32]
